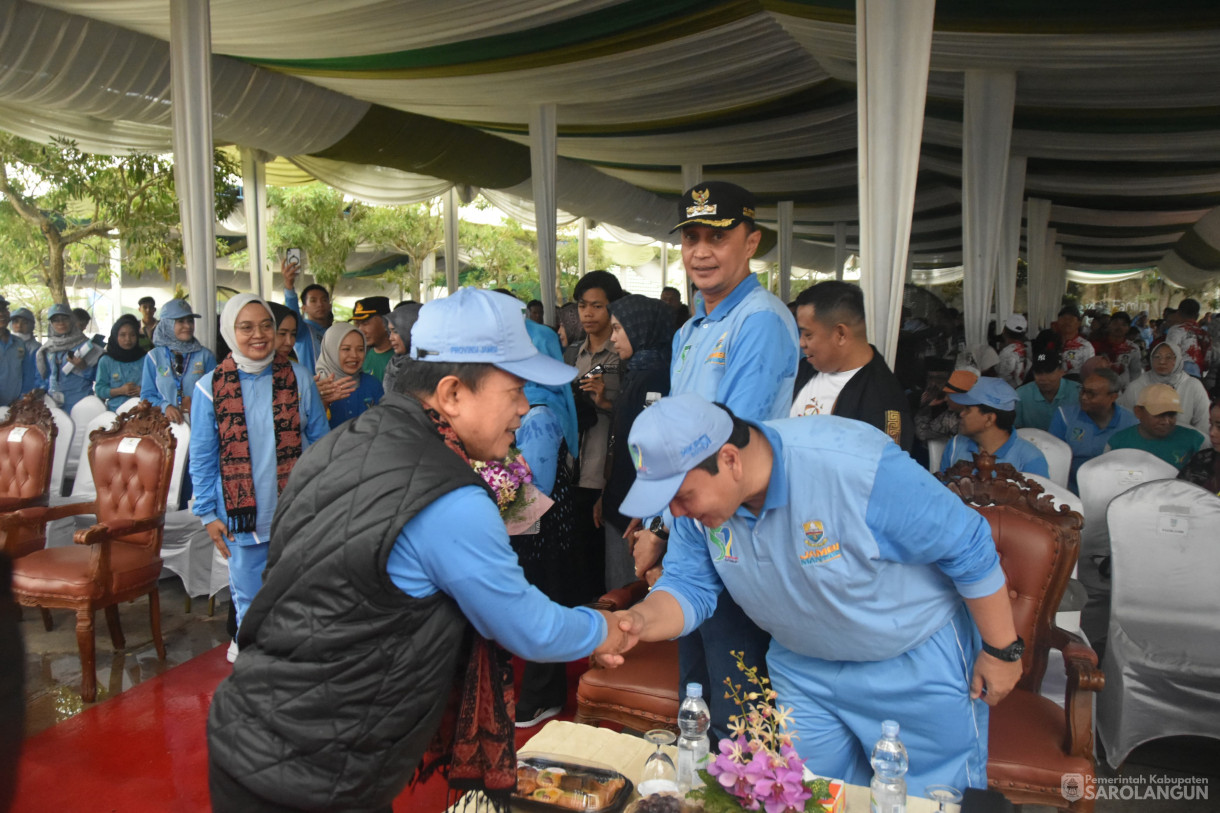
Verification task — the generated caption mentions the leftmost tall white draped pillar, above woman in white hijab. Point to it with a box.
[170,0,216,349]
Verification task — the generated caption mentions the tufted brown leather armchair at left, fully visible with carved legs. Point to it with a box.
[6,402,176,702]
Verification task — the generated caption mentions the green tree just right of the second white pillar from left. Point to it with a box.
[267,183,370,297]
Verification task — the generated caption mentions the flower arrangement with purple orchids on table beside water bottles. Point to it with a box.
[688,652,843,813]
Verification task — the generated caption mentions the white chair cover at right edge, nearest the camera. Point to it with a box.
[1097,480,1220,768]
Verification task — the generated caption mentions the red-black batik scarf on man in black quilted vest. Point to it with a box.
[416,404,517,813]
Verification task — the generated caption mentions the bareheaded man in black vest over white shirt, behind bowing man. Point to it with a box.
[788,281,915,452]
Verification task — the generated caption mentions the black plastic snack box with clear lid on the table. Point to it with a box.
[512,754,633,813]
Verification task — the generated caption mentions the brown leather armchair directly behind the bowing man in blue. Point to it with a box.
[938,453,1105,813]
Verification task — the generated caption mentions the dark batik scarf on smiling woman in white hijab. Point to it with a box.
[212,354,301,533]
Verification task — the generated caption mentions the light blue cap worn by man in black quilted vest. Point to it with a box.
[411,288,576,387]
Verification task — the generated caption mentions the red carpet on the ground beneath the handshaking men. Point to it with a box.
[12,646,584,813]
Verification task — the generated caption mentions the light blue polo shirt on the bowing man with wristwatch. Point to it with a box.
[656,415,1004,662]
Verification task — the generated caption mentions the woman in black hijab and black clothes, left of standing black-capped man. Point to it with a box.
[601,294,673,590]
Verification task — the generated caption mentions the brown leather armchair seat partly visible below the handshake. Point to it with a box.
[575,581,681,734]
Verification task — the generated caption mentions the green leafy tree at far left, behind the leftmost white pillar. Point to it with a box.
[0,133,238,303]
